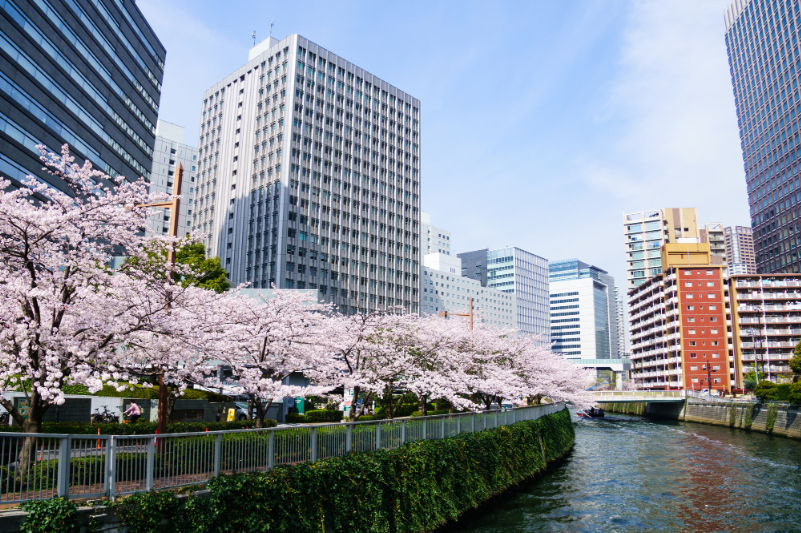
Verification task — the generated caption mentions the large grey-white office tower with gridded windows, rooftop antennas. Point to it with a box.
[193,35,420,313]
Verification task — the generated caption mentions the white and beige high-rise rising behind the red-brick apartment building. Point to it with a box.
[623,207,699,289]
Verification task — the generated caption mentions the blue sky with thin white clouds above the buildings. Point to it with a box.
[137,0,750,300]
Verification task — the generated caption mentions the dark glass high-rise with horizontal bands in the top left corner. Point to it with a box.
[0,0,166,190]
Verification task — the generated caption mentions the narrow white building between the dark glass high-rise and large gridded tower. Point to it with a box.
[147,120,197,237]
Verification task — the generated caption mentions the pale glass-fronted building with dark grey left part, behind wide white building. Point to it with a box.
[457,247,551,340]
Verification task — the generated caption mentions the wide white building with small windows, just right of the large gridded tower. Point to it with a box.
[420,253,517,329]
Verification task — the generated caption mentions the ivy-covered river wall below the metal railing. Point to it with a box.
[156,409,575,533]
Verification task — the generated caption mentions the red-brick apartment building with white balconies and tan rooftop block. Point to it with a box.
[628,243,737,391]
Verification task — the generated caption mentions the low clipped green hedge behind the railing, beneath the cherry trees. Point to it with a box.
[0,418,277,435]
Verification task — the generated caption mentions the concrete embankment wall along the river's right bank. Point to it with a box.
[600,398,801,439]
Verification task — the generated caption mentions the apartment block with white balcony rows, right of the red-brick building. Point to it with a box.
[729,274,801,387]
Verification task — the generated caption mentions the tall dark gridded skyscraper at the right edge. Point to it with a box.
[725,0,801,273]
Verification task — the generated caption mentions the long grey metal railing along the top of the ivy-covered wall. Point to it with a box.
[0,403,565,504]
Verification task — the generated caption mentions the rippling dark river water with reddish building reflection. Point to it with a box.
[456,413,801,533]
